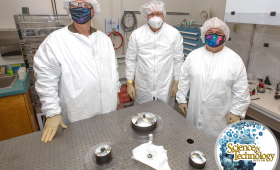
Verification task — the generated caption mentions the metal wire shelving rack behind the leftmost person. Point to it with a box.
[14,15,72,130]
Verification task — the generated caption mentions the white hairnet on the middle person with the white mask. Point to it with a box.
[139,0,166,21]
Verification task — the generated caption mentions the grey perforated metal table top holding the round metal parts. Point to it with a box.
[0,100,218,170]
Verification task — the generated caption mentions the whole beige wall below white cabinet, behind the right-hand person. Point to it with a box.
[226,23,280,81]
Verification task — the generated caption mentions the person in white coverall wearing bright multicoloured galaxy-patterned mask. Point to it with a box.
[176,17,250,140]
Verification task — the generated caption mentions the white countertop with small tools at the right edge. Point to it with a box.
[249,80,280,122]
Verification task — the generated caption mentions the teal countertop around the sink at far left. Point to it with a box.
[0,70,32,97]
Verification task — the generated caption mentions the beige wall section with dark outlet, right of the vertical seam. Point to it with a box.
[248,25,280,84]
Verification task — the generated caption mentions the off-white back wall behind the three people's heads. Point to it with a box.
[0,0,226,55]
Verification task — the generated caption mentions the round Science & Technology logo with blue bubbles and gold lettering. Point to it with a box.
[214,120,279,170]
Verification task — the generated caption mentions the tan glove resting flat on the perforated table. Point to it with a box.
[41,114,67,142]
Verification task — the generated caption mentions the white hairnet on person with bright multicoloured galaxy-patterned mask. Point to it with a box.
[201,17,230,43]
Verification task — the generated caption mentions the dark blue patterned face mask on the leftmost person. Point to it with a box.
[70,8,92,24]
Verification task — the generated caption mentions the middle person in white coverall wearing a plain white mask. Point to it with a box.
[125,1,184,107]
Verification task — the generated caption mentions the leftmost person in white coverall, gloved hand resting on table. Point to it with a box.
[34,0,120,142]
